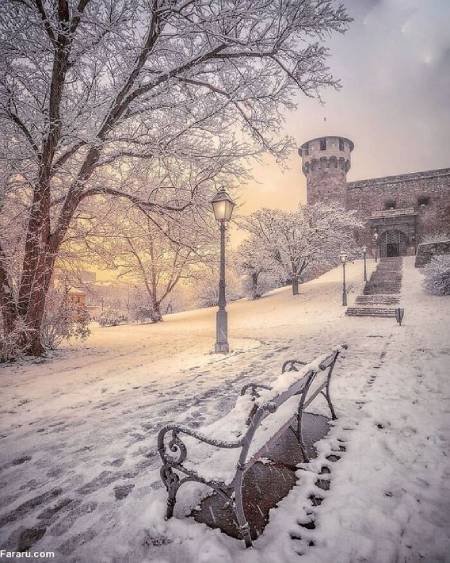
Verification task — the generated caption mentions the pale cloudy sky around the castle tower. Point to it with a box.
[233,0,450,219]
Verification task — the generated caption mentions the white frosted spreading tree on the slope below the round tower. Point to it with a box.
[240,204,361,295]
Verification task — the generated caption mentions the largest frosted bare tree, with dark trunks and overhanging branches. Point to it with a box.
[0,0,349,354]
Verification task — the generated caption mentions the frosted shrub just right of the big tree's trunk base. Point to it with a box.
[41,290,90,350]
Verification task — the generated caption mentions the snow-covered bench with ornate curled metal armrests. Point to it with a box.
[158,344,347,547]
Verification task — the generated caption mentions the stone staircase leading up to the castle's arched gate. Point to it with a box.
[345,257,402,317]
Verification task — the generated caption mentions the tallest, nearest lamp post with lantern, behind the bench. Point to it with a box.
[211,188,235,354]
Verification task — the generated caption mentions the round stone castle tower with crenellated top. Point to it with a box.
[298,136,353,207]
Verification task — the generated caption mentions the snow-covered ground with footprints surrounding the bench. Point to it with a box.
[0,258,450,563]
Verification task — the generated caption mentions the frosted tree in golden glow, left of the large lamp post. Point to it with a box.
[88,205,215,322]
